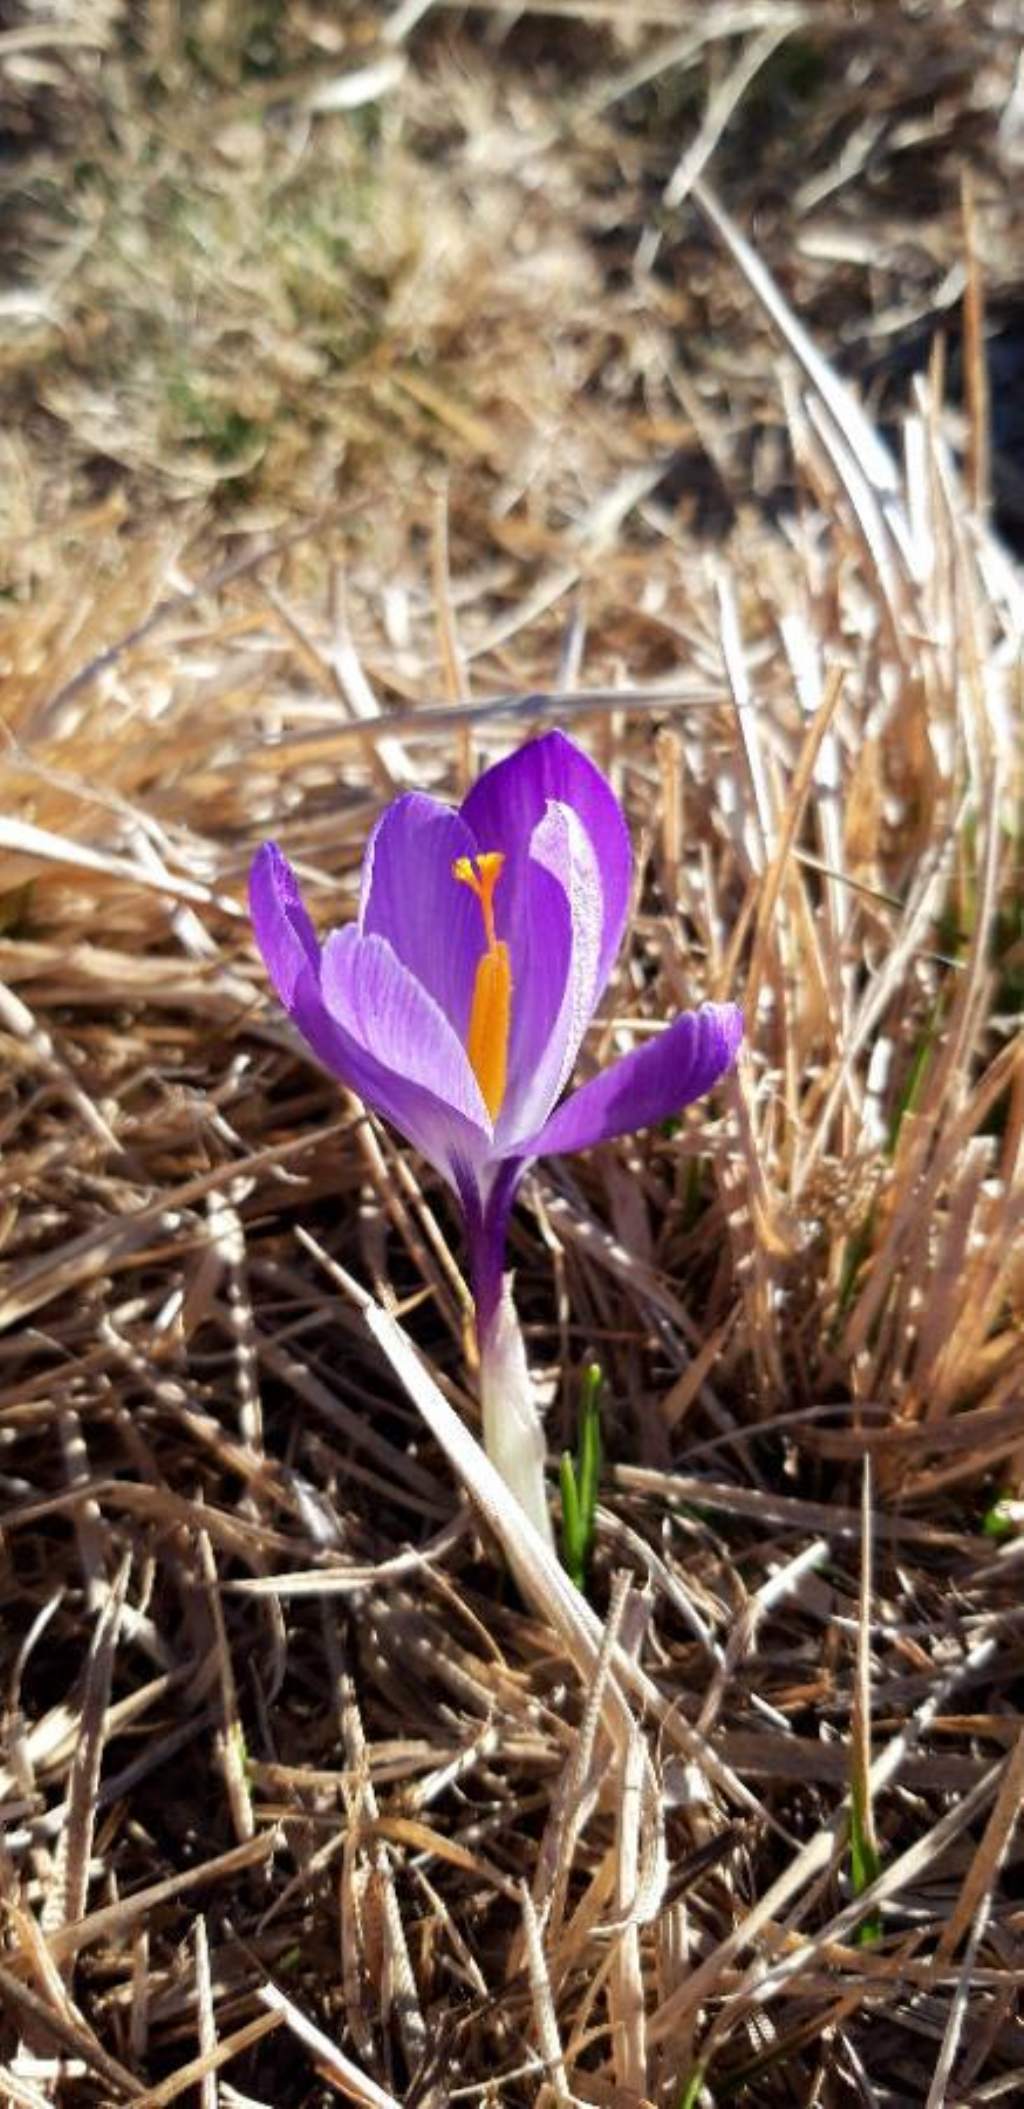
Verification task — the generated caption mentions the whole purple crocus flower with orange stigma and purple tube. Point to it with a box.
[251,732,744,1346]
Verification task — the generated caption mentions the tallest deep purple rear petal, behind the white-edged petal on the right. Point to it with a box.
[461,732,632,1000]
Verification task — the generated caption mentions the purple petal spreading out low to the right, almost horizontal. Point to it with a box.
[529,1004,744,1158]
